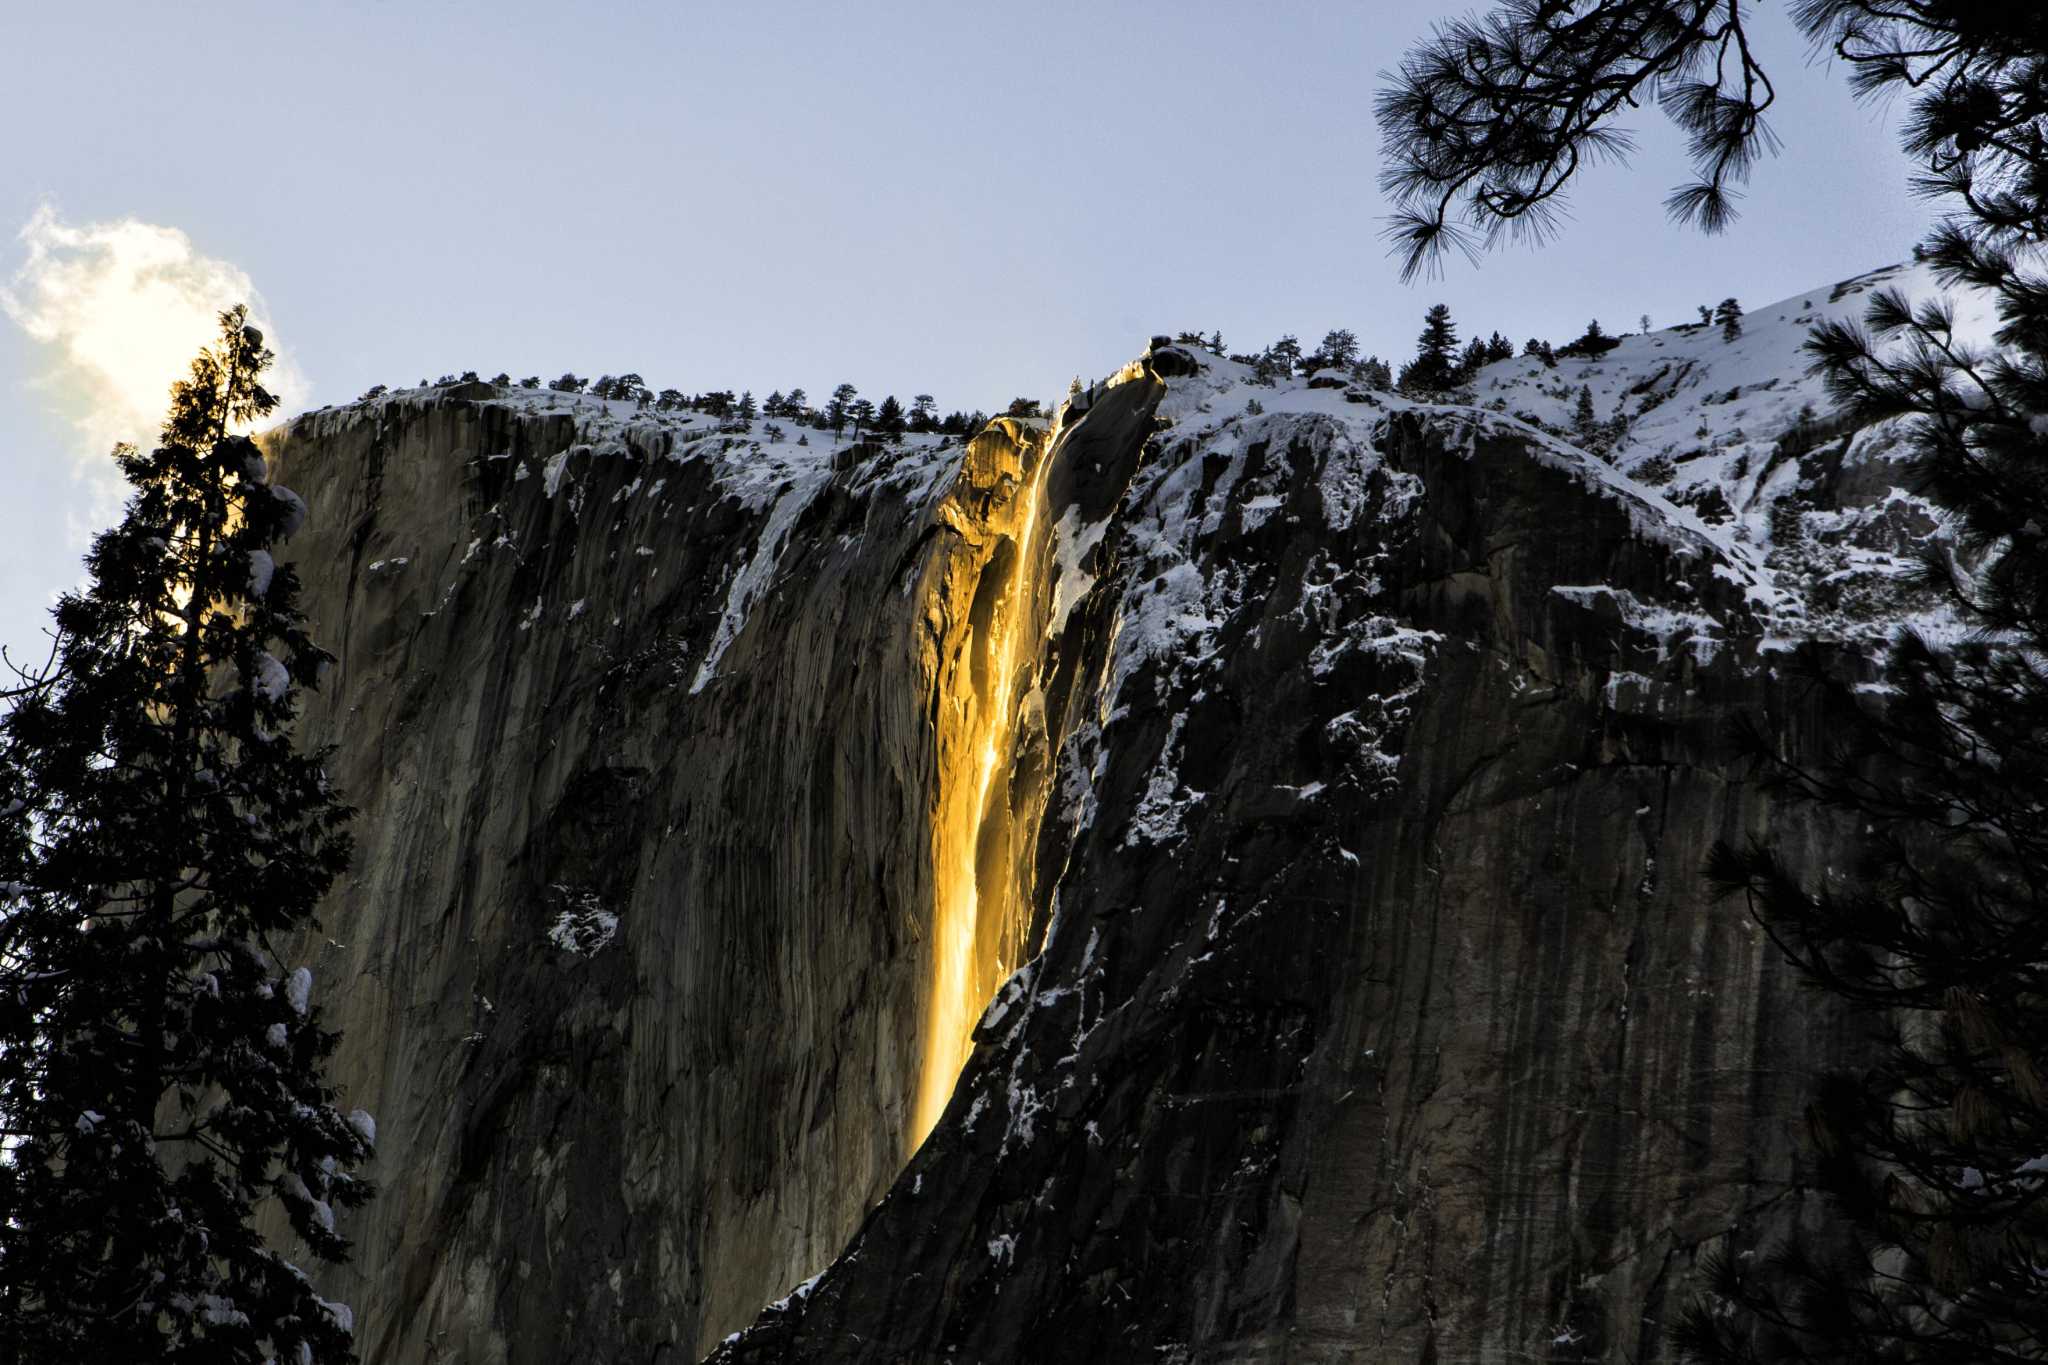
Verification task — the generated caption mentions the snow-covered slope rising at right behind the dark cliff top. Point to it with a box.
[1122,264,1997,641]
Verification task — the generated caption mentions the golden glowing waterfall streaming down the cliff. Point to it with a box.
[909,428,1053,1150]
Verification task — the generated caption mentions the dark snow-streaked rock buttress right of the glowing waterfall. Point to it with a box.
[717,388,1843,1363]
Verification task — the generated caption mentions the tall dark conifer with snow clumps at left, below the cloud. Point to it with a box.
[0,309,375,1365]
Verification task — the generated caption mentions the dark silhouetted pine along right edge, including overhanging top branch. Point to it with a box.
[1380,0,2048,1365]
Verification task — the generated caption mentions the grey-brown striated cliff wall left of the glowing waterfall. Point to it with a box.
[270,389,1042,1363]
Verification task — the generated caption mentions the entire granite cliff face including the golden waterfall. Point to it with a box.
[270,280,1929,1365]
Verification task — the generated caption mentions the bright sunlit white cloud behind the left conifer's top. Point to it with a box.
[0,205,307,501]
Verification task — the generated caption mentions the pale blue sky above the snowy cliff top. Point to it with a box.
[0,0,1927,667]
